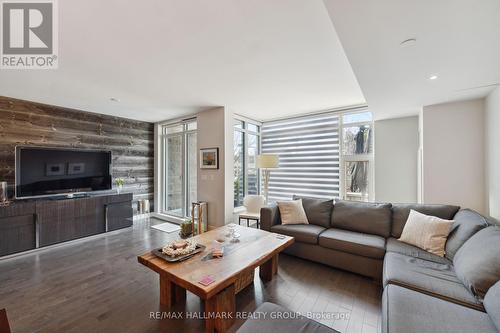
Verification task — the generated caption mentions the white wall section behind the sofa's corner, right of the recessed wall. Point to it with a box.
[421,99,486,213]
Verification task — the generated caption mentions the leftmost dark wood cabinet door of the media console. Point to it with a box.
[0,214,36,256]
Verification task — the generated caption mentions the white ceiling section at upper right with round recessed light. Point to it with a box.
[324,0,500,119]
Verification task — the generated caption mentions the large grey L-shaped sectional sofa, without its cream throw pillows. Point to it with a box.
[261,198,500,333]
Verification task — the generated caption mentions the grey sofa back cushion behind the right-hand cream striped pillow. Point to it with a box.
[391,204,460,238]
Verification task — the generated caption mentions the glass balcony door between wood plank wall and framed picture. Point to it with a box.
[162,121,198,217]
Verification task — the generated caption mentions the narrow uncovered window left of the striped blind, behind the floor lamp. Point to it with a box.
[234,119,261,207]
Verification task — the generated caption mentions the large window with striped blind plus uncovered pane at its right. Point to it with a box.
[262,112,373,201]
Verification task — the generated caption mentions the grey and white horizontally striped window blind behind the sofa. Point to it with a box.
[262,113,340,201]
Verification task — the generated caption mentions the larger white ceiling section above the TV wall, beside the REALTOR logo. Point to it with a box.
[0,0,365,121]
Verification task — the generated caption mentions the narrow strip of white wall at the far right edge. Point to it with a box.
[485,87,500,221]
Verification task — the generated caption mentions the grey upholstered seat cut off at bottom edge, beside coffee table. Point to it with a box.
[236,302,338,333]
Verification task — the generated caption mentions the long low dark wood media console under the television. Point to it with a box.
[0,193,133,256]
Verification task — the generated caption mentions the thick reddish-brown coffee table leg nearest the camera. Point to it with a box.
[205,284,236,333]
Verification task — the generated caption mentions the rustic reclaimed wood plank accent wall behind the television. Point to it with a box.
[0,96,154,208]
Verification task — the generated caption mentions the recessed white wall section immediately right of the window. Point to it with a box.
[375,116,419,203]
